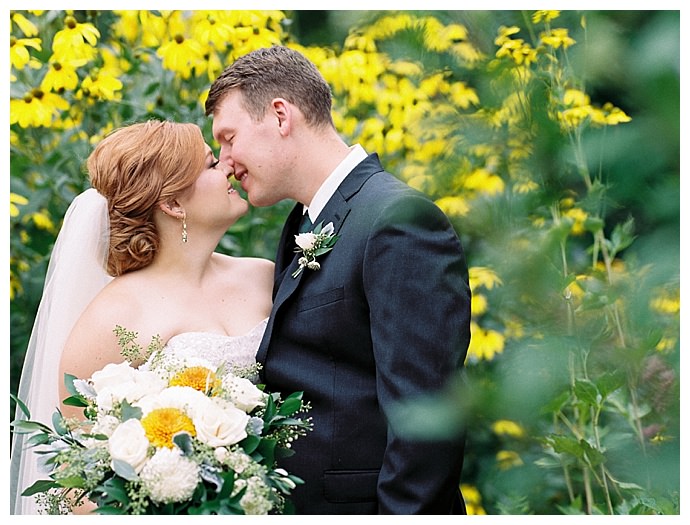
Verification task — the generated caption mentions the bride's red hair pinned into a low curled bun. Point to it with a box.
[86,120,206,276]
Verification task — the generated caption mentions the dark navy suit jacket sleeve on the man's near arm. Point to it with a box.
[363,191,470,514]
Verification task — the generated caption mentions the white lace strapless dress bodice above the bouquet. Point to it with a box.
[164,319,268,368]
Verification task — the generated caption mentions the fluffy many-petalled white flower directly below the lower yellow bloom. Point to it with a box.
[139,447,199,503]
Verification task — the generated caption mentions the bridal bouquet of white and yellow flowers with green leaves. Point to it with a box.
[12,327,311,514]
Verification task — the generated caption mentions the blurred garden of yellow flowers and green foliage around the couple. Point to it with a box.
[10,11,680,514]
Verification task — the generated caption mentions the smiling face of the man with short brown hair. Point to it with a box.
[208,91,289,206]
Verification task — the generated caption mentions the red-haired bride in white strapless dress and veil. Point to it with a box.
[10,117,273,514]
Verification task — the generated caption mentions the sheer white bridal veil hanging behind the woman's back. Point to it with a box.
[10,189,112,514]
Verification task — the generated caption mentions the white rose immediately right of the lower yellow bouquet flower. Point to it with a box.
[192,400,249,447]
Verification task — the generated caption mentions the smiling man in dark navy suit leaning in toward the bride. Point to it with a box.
[206,46,470,514]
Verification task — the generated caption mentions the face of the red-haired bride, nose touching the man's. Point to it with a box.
[184,145,249,229]
